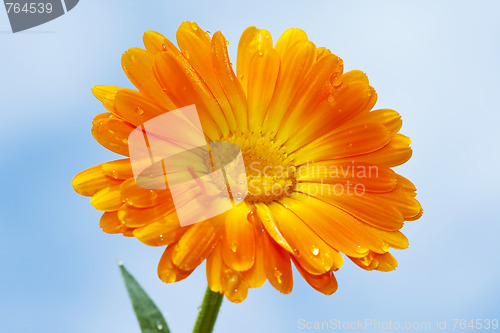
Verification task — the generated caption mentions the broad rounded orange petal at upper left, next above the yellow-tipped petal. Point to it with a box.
[122,47,177,110]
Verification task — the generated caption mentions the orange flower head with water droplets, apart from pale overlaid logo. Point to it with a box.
[73,22,422,302]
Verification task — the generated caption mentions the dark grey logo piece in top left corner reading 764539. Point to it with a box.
[4,0,79,33]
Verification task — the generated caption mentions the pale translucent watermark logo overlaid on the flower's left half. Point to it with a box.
[128,105,248,226]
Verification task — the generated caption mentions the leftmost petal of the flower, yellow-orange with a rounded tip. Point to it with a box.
[71,164,121,197]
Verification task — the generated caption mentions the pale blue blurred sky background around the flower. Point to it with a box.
[0,0,500,333]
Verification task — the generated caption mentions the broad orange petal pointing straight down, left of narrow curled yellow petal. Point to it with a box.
[221,202,255,271]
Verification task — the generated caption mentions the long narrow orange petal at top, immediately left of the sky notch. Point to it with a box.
[212,31,248,131]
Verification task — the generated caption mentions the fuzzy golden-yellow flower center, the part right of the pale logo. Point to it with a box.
[222,132,296,203]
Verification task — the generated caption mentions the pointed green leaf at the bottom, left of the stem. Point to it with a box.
[118,261,170,333]
